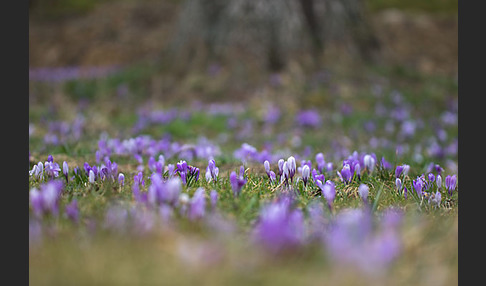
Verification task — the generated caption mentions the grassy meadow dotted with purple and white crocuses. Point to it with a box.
[25,66,459,285]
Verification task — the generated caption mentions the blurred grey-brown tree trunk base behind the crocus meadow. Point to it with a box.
[173,0,379,72]
